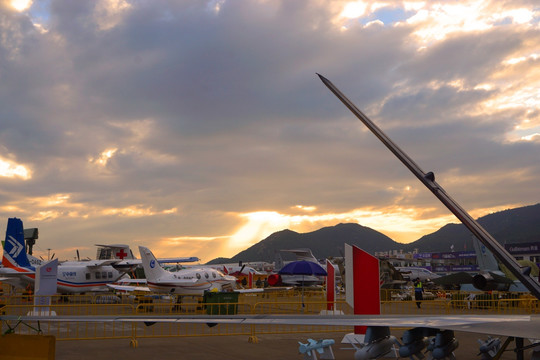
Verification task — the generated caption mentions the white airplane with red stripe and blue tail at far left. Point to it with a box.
[0,218,133,293]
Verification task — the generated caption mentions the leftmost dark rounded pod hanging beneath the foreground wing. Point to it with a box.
[354,326,396,360]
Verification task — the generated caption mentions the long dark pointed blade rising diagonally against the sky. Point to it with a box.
[317,74,540,299]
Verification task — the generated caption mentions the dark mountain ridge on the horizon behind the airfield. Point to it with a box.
[210,203,540,263]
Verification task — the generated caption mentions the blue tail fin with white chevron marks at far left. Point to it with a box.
[2,218,32,268]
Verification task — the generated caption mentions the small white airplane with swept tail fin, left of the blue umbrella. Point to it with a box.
[109,246,236,295]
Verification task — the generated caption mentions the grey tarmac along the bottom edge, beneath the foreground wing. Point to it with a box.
[52,330,530,360]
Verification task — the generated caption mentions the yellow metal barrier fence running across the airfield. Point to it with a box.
[0,290,540,346]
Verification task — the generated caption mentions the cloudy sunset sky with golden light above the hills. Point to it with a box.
[0,0,540,262]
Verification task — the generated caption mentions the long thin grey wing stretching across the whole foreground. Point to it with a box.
[0,315,540,339]
